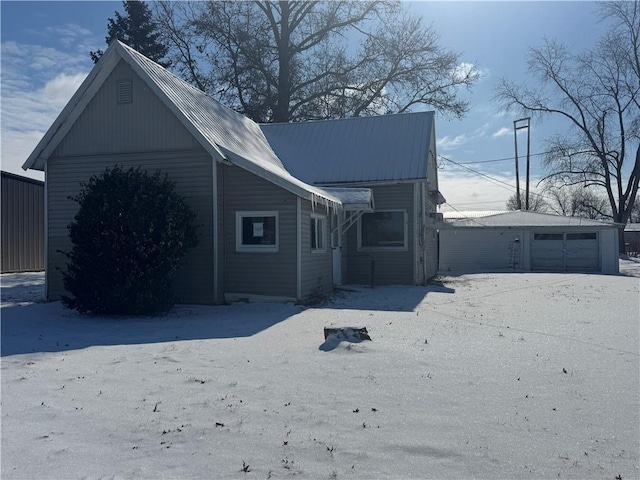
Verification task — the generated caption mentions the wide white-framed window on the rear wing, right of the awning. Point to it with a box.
[358,210,408,250]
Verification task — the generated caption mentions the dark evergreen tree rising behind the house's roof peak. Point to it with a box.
[90,1,169,67]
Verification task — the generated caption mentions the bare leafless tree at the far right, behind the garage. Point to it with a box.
[497,0,640,252]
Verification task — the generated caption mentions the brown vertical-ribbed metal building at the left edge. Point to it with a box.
[0,172,44,273]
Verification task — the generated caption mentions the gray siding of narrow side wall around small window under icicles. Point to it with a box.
[300,200,333,300]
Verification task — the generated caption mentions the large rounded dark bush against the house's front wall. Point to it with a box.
[62,165,198,315]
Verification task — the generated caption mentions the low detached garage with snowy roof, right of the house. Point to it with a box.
[439,211,618,274]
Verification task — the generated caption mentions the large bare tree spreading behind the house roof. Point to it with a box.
[156,1,479,122]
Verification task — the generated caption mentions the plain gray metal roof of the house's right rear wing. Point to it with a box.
[260,112,435,185]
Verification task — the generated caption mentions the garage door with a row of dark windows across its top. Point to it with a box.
[531,232,600,272]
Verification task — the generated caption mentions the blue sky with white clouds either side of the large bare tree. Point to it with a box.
[0,1,606,210]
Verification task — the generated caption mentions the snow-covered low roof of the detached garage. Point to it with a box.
[449,211,615,228]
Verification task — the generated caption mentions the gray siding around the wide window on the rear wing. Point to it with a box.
[345,183,415,285]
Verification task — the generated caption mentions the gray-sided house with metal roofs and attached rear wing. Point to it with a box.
[24,41,443,304]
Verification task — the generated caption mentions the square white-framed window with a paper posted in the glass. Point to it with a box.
[236,211,278,252]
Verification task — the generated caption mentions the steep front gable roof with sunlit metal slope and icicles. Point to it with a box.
[22,40,370,210]
